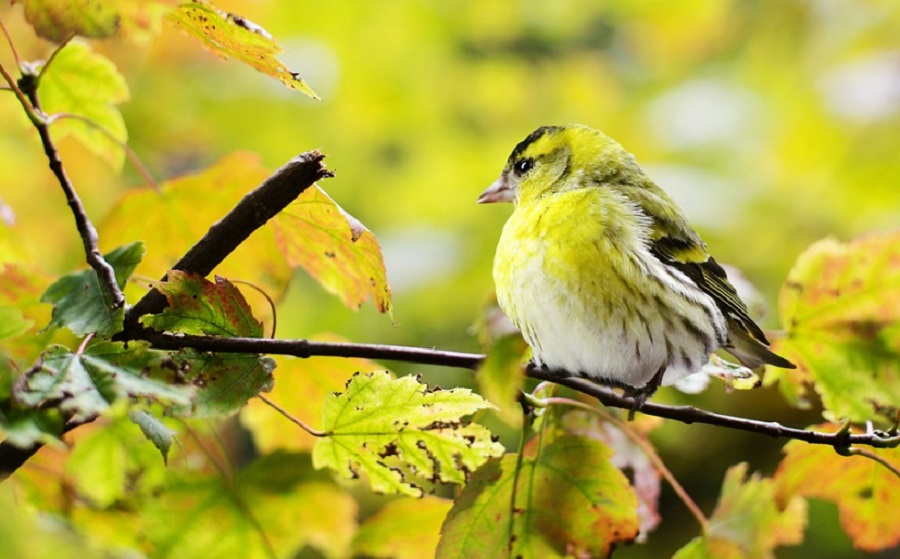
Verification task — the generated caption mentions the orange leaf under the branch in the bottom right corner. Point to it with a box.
[774,424,900,553]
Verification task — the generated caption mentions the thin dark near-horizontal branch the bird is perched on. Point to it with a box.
[130,330,900,449]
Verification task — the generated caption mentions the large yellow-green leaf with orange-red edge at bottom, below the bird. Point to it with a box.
[437,435,638,559]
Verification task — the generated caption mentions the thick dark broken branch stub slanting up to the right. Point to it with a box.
[117,150,334,339]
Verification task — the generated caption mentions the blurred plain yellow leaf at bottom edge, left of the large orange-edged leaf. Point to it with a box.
[353,495,453,559]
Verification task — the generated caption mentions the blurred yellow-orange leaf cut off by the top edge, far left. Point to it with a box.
[13,0,173,43]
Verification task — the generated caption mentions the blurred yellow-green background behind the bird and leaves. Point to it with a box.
[0,0,900,558]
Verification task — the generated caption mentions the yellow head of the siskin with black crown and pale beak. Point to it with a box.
[478,124,634,204]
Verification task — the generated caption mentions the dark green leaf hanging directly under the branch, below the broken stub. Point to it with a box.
[172,349,275,416]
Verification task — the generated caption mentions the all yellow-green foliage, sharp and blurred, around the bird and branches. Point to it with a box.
[0,0,900,559]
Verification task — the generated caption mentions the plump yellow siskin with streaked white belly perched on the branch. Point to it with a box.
[478,125,794,408]
